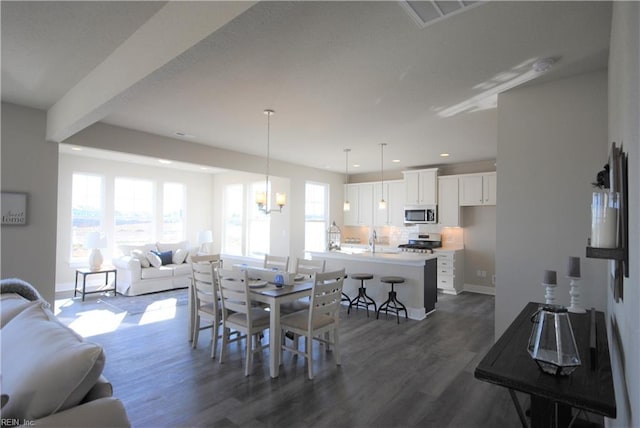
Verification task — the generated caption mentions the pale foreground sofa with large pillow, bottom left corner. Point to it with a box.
[0,292,131,427]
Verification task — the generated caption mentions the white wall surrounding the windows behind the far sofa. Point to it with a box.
[56,154,215,291]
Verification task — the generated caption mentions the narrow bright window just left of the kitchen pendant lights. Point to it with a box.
[304,183,329,251]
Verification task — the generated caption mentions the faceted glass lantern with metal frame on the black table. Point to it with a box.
[527,305,581,376]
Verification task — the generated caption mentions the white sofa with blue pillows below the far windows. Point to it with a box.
[112,241,197,296]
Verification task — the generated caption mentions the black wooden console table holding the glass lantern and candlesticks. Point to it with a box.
[475,302,616,428]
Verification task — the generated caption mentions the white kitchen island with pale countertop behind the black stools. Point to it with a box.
[310,251,438,320]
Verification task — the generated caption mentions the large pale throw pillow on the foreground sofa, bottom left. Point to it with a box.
[0,305,105,420]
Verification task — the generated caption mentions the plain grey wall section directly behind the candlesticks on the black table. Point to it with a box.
[495,72,607,338]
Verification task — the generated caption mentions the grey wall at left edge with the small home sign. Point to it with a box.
[0,103,58,303]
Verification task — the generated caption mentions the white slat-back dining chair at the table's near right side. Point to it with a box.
[280,269,344,379]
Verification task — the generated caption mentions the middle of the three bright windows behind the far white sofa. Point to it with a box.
[114,178,155,244]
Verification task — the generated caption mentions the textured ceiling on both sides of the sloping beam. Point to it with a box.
[2,1,611,172]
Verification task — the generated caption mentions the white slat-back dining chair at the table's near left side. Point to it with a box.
[218,269,269,376]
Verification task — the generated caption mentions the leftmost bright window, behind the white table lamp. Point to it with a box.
[71,173,104,259]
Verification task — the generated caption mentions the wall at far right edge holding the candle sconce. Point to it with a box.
[603,2,640,427]
